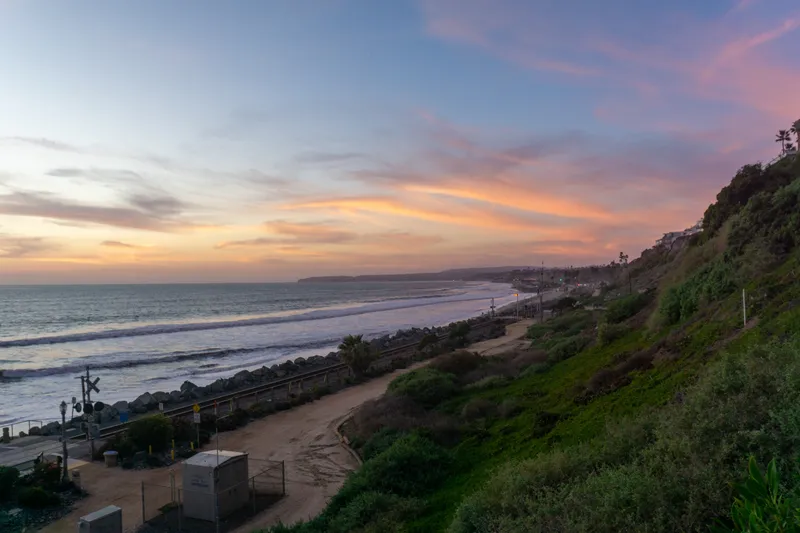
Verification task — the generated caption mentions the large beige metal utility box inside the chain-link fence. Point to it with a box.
[182,450,250,522]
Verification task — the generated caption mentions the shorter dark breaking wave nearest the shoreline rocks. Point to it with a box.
[0,339,339,380]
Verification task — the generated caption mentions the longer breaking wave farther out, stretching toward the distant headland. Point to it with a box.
[0,286,504,348]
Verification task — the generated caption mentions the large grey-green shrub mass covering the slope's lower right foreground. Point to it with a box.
[450,342,800,533]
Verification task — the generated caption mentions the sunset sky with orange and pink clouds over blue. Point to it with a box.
[0,0,800,284]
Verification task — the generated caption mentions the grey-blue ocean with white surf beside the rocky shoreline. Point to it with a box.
[0,282,515,427]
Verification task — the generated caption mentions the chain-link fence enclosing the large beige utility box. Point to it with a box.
[138,457,286,533]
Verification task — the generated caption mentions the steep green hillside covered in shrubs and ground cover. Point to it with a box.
[258,154,800,533]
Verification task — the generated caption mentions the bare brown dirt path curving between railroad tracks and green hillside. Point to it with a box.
[40,320,533,533]
